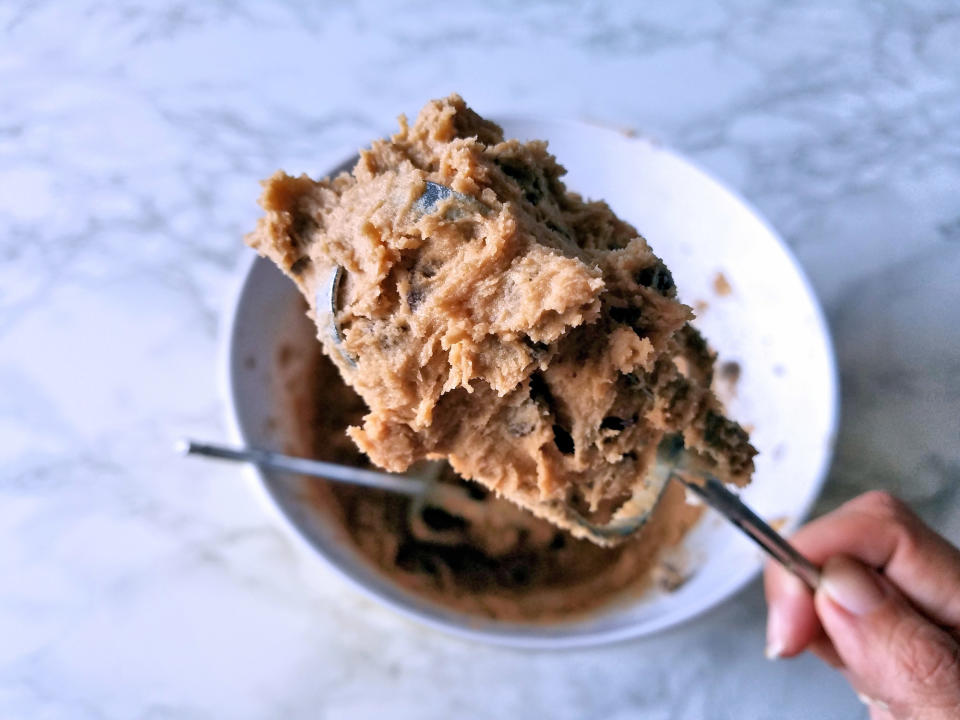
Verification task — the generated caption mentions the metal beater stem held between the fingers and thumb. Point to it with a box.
[675,473,820,590]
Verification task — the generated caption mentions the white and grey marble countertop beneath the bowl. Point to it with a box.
[0,0,960,720]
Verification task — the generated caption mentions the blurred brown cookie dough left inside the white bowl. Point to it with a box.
[276,343,703,623]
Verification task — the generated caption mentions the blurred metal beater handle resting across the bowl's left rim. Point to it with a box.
[177,440,427,495]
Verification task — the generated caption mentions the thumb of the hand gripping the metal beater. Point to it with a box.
[815,555,960,718]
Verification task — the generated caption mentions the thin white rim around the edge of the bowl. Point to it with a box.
[217,114,840,650]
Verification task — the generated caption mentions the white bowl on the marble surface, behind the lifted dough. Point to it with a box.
[222,118,837,648]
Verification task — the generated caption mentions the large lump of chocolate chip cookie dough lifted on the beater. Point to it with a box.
[247,95,755,540]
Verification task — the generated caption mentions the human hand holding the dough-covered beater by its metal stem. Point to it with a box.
[764,491,960,720]
